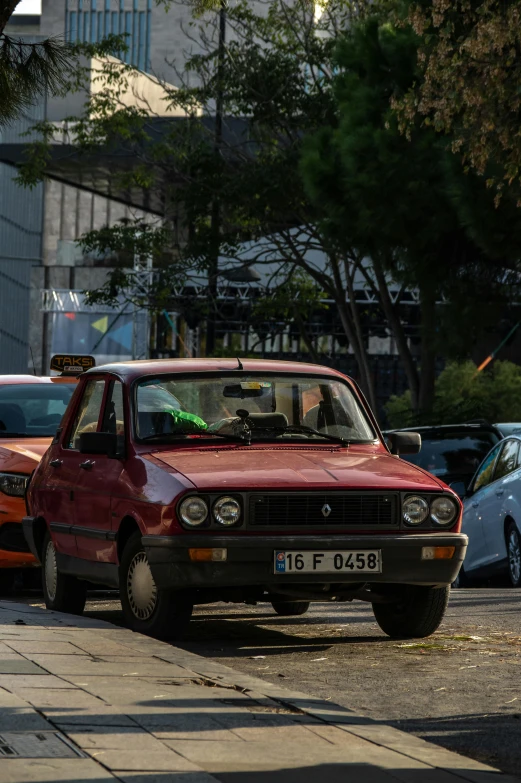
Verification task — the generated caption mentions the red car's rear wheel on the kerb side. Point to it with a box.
[42,532,87,614]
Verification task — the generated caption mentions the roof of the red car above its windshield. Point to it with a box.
[85,358,352,381]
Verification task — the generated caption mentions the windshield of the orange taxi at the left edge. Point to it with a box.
[0,383,76,438]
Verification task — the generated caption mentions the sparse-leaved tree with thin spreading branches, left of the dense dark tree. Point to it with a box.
[16,0,384,414]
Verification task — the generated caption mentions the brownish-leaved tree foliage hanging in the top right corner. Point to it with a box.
[395,0,521,200]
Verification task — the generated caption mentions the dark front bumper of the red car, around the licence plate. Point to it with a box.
[142,533,468,591]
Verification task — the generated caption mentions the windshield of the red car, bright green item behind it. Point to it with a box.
[136,374,376,443]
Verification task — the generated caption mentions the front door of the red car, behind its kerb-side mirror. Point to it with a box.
[74,378,124,563]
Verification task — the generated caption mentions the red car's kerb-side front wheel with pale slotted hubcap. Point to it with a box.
[119,532,193,641]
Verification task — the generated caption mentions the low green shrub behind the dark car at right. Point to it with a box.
[385,361,521,427]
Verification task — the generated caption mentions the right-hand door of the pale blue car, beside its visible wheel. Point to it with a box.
[483,438,521,568]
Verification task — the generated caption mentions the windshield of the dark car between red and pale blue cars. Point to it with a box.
[403,431,499,478]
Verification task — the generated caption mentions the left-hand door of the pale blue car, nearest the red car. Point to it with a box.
[462,443,502,573]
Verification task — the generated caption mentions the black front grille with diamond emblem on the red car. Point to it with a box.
[248,492,399,529]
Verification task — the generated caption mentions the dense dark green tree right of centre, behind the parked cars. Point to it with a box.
[302,15,520,412]
